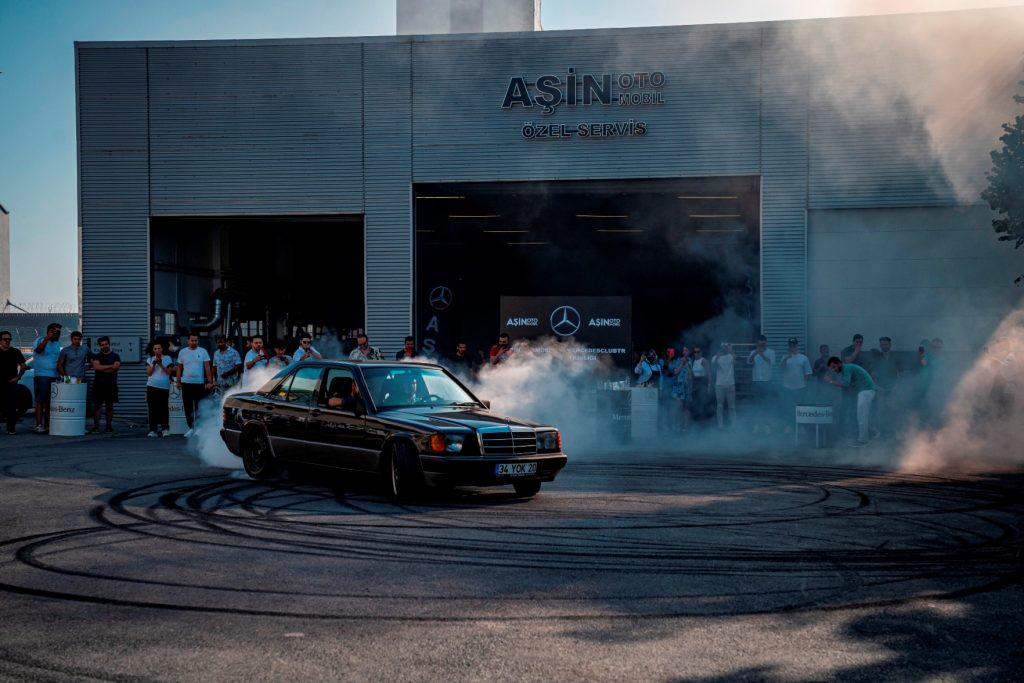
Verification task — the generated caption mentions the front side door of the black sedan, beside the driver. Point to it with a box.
[307,368,376,471]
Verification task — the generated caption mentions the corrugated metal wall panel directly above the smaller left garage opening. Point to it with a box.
[150,43,362,215]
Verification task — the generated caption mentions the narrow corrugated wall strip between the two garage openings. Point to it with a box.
[362,43,414,349]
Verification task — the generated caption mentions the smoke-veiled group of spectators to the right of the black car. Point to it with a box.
[633,334,1018,446]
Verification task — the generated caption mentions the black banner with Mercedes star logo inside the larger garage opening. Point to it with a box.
[499,296,633,365]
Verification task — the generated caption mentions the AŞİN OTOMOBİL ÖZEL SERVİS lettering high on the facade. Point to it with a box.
[502,67,666,140]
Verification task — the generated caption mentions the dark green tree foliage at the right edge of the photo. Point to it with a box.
[981,66,1024,272]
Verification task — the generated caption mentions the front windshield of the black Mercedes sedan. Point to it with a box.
[362,365,478,408]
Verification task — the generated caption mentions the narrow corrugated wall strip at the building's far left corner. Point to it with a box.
[76,47,150,414]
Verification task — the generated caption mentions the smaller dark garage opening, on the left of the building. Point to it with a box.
[150,216,366,349]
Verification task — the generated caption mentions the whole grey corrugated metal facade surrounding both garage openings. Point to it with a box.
[78,10,1015,417]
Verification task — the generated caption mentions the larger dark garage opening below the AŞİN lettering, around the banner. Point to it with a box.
[415,177,761,362]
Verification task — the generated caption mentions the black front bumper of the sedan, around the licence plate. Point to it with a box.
[420,453,568,486]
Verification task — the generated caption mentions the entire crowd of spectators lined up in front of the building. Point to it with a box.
[6,323,1018,445]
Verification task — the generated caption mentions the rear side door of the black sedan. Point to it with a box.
[263,366,324,462]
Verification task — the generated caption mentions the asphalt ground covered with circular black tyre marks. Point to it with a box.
[0,423,1024,682]
